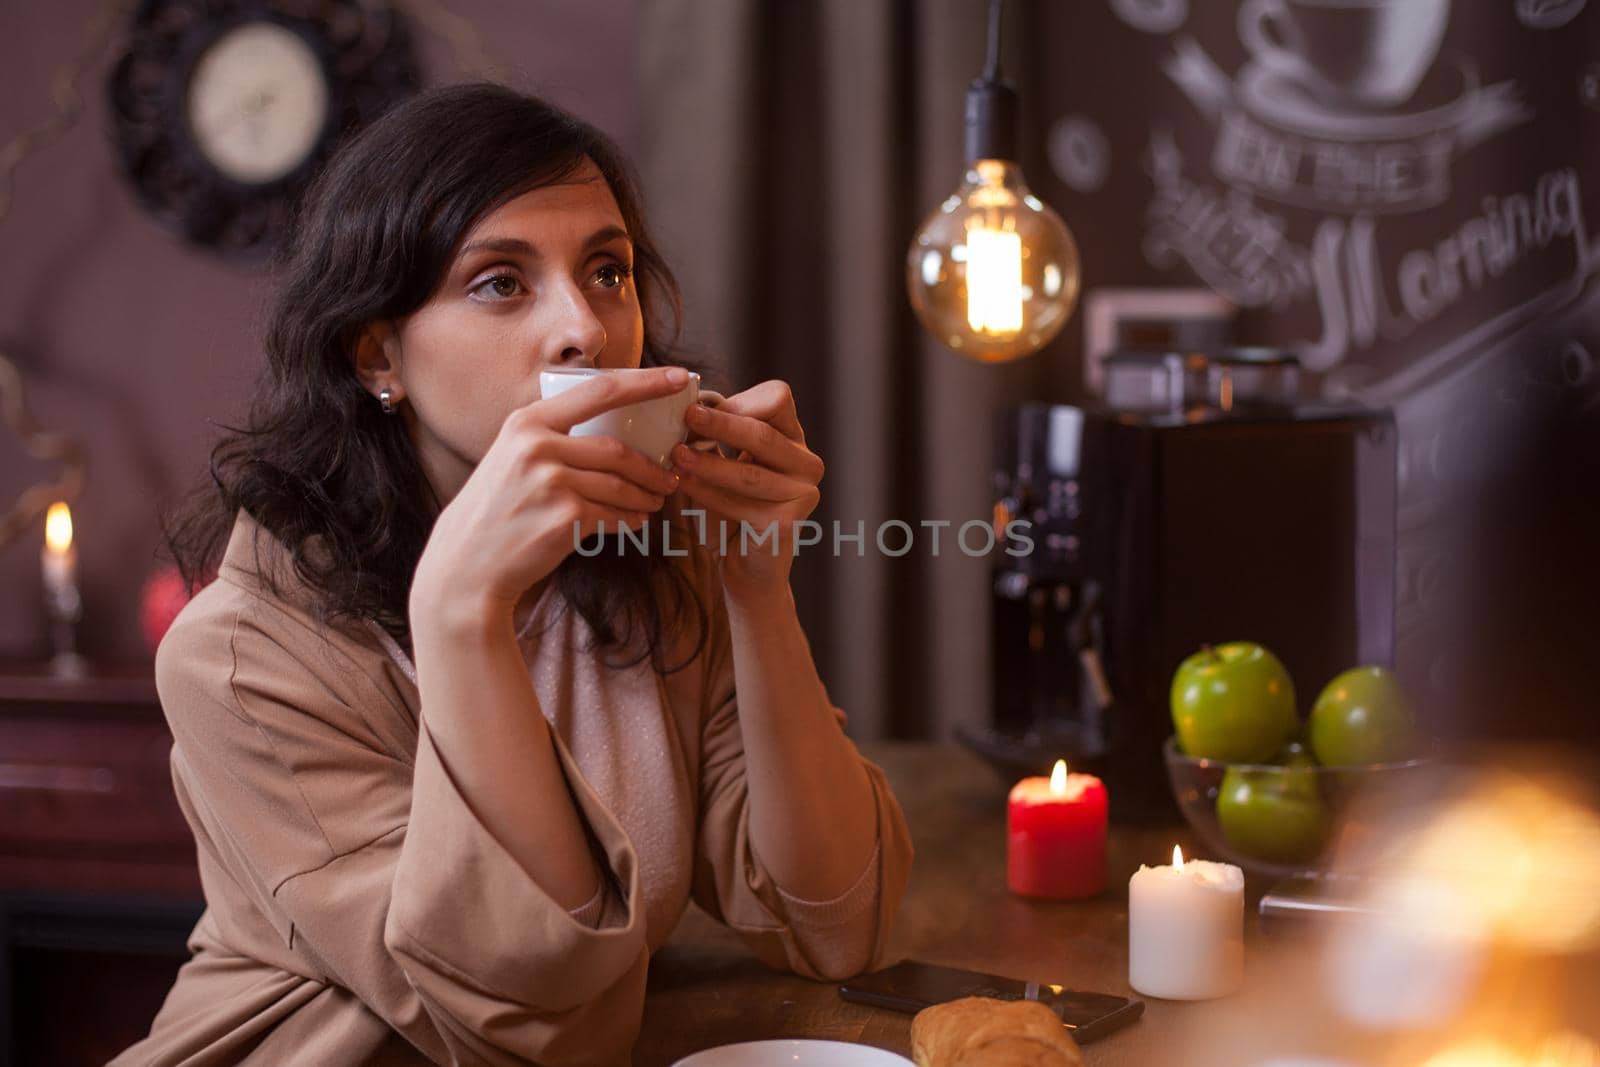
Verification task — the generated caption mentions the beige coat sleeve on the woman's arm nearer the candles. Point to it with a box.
[693,572,912,981]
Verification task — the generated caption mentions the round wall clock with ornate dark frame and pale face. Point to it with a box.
[107,0,418,259]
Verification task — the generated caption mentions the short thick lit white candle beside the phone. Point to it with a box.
[1128,848,1245,1000]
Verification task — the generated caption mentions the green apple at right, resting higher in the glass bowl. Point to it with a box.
[1310,667,1416,766]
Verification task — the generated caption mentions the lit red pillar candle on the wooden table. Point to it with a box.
[1006,760,1106,901]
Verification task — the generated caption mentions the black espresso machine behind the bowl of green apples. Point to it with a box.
[958,349,1397,821]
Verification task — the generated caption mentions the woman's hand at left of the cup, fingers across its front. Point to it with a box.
[411,366,688,627]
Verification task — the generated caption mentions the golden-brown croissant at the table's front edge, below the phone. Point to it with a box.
[910,997,1083,1067]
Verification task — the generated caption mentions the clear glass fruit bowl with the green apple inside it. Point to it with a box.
[1163,736,1432,878]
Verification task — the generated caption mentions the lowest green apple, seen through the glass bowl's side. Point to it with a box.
[1216,757,1328,864]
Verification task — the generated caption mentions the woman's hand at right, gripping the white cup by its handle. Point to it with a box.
[672,379,822,597]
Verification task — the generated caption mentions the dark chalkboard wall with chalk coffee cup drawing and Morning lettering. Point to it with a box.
[1024,0,1600,733]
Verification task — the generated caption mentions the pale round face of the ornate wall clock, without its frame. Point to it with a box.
[187,21,328,186]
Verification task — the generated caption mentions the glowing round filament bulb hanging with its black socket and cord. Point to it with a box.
[906,0,1078,363]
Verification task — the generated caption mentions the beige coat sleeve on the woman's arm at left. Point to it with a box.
[157,601,650,1065]
